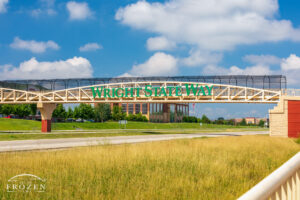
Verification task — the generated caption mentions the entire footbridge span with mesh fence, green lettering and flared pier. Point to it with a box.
[0,75,292,135]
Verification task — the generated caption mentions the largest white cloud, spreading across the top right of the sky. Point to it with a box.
[115,0,300,50]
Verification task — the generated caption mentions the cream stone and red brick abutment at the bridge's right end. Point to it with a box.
[269,96,300,138]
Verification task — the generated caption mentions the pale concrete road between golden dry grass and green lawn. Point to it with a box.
[0,131,269,152]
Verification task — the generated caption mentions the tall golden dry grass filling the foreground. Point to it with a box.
[0,136,300,199]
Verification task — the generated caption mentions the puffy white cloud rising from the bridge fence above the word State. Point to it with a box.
[123,52,178,76]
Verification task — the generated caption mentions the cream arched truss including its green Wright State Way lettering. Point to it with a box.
[0,80,281,104]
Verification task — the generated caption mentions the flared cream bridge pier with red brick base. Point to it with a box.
[37,103,56,133]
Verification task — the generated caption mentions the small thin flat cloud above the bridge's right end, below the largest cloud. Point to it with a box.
[243,55,281,65]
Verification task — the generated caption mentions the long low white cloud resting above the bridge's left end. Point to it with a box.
[0,57,93,80]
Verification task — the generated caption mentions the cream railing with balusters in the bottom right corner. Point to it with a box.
[238,152,300,200]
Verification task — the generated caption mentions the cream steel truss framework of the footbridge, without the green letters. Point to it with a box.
[0,81,282,104]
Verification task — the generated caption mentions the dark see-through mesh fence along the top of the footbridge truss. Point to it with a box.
[0,75,287,91]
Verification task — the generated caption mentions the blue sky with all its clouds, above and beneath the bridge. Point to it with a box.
[0,0,300,117]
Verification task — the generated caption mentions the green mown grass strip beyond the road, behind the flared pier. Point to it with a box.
[0,119,267,141]
